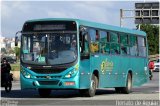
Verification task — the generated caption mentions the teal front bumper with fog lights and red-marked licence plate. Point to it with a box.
[20,74,79,89]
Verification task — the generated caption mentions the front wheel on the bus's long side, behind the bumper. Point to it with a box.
[80,74,98,97]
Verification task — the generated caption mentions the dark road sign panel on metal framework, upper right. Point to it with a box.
[135,2,160,24]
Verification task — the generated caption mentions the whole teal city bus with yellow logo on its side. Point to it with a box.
[15,18,149,97]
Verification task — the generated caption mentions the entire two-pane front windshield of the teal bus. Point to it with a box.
[21,33,77,65]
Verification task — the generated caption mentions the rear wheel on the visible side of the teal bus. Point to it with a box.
[121,73,132,94]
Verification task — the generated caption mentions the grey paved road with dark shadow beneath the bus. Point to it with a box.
[1,72,159,106]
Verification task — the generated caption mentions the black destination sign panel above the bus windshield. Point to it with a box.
[22,21,77,32]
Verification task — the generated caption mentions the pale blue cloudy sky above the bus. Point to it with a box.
[0,0,157,38]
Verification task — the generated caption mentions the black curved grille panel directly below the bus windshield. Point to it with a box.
[32,68,66,74]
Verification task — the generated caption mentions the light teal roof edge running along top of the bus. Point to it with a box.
[26,18,146,36]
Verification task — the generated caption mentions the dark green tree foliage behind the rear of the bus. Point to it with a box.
[138,24,159,55]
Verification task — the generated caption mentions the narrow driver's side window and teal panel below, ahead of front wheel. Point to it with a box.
[79,28,90,89]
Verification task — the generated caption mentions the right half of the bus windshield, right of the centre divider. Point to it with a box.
[48,34,77,65]
